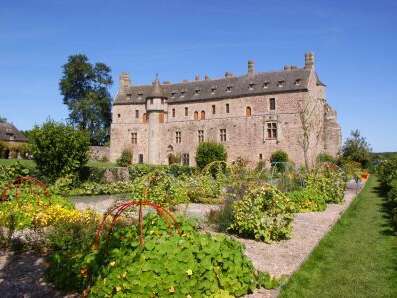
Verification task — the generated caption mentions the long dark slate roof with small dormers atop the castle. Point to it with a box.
[114,68,323,105]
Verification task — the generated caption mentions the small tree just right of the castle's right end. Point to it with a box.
[342,129,372,168]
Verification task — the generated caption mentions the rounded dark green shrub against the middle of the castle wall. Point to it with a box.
[196,142,227,169]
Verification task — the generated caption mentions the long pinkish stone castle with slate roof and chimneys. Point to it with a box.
[110,52,341,166]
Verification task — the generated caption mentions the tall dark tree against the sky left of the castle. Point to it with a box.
[59,54,113,145]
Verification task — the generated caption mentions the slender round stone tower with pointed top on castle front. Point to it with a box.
[146,77,167,164]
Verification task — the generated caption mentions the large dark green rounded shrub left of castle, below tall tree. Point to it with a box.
[31,120,89,182]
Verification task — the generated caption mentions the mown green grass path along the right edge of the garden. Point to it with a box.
[279,176,397,297]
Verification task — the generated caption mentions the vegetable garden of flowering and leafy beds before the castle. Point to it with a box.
[0,160,366,297]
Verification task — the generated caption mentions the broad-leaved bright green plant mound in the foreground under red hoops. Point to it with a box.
[48,214,275,297]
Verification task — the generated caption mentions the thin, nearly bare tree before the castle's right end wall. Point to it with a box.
[298,98,323,169]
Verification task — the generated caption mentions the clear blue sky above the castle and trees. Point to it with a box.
[0,0,397,151]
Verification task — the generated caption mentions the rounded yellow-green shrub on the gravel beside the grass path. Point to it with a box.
[229,185,293,242]
